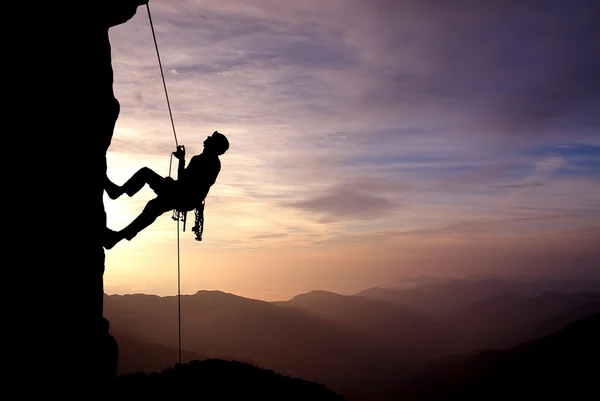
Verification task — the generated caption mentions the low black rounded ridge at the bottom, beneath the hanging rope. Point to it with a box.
[114,359,345,401]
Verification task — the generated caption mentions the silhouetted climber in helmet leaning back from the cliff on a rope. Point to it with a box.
[104,131,229,249]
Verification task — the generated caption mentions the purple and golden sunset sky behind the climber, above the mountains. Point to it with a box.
[105,0,600,300]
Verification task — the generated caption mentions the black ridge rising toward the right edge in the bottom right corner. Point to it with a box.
[390,314,600,401]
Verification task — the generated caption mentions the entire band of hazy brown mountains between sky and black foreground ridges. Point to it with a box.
[105,280,600,400]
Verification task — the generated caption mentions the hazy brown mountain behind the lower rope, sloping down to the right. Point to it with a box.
[104,291,407,393]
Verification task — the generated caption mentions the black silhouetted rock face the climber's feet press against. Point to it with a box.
[13,0,147,395]
